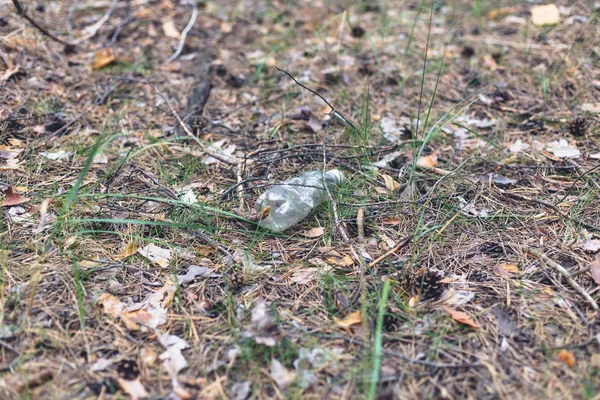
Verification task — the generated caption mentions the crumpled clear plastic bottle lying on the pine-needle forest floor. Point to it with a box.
[256,169,344,232]
